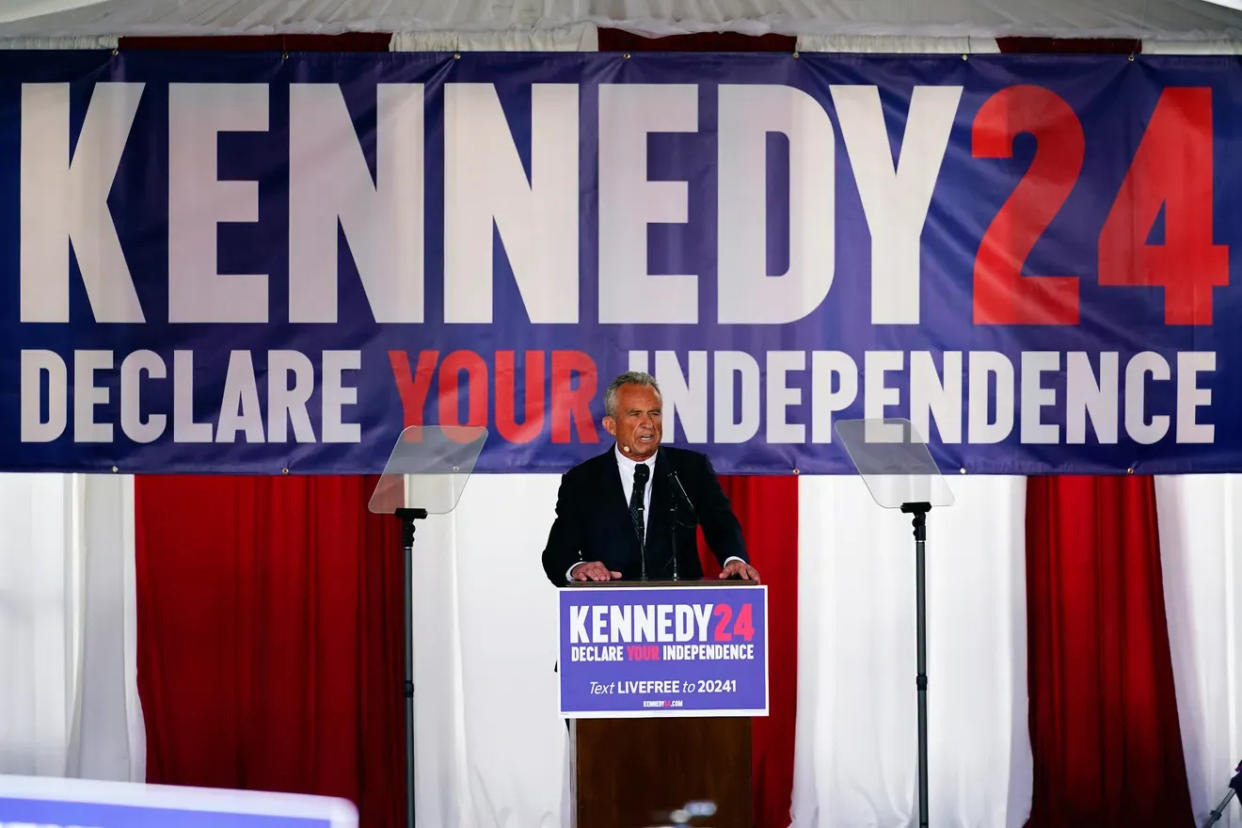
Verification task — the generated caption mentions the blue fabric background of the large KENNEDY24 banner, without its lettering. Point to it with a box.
[0,52,1242,474]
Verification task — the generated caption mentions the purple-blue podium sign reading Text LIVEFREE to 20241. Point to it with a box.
[559,581,768,719]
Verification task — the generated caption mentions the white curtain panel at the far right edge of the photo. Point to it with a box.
[1156,474,1242,828]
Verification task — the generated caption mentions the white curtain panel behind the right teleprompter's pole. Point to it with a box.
[794,477,1032,828]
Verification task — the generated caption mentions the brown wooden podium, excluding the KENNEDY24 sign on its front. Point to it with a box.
[570,581,753,828]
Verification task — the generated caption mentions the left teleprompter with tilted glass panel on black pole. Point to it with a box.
[366,426,487,828]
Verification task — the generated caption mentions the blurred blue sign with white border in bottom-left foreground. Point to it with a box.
[0,776,358,828]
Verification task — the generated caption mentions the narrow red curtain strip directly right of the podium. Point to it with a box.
[699,475,797,828]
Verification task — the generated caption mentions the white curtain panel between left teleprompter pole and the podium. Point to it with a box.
[414,474,569,828]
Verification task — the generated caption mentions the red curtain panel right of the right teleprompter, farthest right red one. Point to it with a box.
[1026,477,1194,828]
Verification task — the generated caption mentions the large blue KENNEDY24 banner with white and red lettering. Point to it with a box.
[0,52,1242,473]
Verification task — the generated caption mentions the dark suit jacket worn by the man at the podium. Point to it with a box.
[543,446,750,586]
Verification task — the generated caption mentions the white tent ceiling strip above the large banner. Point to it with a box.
[0,0,1242,41]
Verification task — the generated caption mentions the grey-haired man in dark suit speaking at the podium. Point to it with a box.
[543,371,759,586]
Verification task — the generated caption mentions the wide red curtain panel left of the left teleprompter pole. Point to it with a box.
[134,477,405,826]
